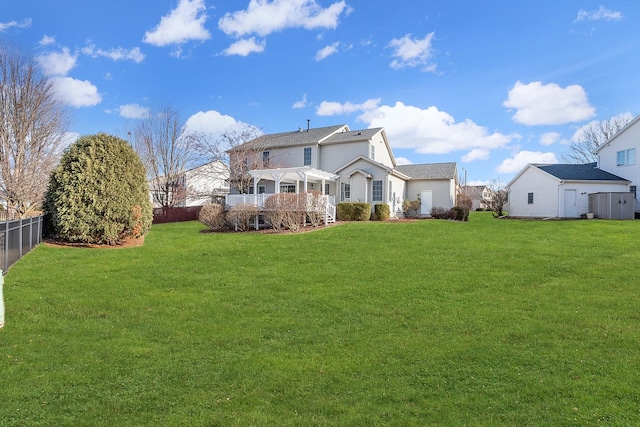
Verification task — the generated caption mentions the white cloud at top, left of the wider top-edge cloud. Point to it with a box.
[143,0,211,47]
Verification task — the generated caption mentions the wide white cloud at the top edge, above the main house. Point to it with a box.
[218,0,351,37]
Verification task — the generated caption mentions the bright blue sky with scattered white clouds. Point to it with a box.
[0,0,640,184]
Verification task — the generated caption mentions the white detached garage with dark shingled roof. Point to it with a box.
[507,163,630,218]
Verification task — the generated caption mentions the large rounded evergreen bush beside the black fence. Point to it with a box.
[44,133,153,245]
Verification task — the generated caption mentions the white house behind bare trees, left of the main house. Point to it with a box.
[149,160,229,208]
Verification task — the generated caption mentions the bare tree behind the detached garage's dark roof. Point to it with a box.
[562,113,633,163]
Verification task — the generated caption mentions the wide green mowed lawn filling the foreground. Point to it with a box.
[0,213,640,426]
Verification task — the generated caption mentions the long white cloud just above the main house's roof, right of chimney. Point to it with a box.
[324,99,520,157]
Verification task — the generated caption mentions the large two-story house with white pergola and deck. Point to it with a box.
[227,125,457,216]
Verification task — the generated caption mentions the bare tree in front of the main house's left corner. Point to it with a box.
[197,126,264,193]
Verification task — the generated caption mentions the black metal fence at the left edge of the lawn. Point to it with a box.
[0,215,43,274]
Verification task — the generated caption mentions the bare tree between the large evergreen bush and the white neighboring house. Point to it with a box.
[133,107,198,208]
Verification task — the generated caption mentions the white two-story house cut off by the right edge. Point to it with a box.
[596,116,640,212]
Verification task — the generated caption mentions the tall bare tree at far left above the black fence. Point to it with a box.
[0,44,69,218]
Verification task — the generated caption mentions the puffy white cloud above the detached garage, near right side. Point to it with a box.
[503,81,595,126]
